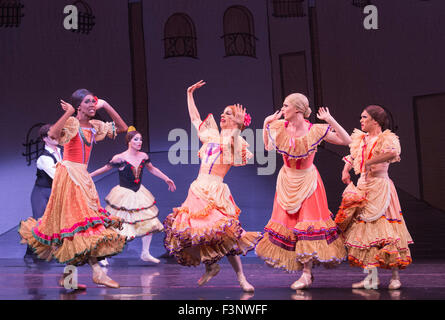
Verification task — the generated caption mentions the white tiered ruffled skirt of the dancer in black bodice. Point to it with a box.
[105,185,164,240]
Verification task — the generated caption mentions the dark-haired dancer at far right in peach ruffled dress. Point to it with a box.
[335,105,413,289]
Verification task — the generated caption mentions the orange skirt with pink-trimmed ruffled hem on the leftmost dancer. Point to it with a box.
[18,161,126,266]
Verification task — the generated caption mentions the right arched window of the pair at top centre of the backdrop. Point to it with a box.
[222,6,257,58]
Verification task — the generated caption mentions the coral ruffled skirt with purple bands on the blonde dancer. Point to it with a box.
[256,167,346,272]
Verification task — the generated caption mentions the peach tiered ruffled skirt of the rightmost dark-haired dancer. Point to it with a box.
[336,177,413,269]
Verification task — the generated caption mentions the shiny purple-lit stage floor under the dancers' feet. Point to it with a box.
[0,257,445,300]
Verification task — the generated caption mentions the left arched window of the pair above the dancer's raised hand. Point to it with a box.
[163,13,198,59]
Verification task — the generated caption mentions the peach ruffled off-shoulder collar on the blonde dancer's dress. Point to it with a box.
[266,120,331,159]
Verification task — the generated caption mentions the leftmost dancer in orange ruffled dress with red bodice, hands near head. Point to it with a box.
[19,89,127,289]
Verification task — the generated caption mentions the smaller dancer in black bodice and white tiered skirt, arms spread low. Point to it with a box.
[91,126,176,263]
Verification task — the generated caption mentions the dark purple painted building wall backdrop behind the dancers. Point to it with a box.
[0,0,445,234]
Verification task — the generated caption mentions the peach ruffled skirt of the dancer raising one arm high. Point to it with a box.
[164,173,262,266]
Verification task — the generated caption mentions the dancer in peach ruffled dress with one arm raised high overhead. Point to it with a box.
[164,80,261,292]
